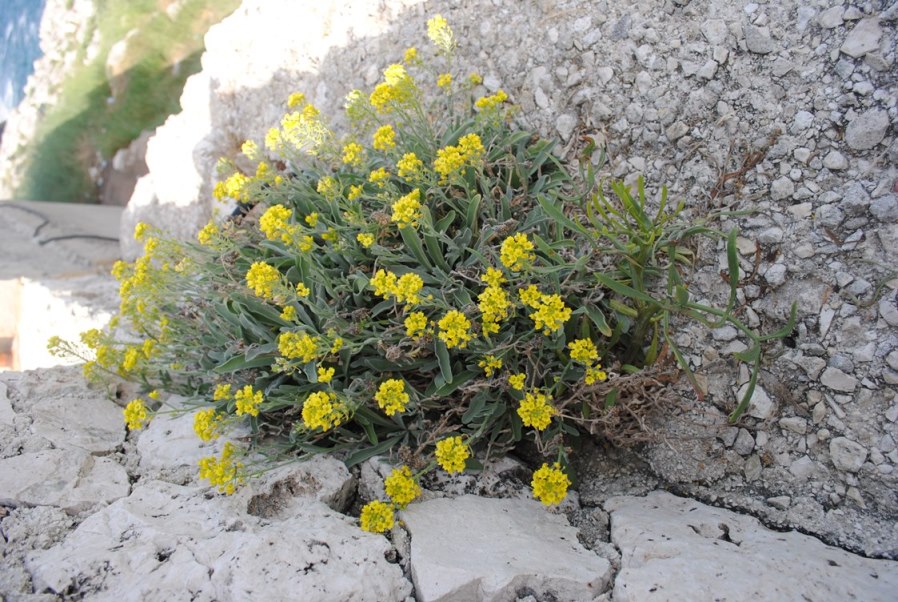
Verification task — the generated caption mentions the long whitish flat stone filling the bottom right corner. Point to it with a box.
[605,491,898,602]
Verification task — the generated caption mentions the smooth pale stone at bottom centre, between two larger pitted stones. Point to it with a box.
[402,495,611,602]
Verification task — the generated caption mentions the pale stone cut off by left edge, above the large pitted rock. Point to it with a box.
[0,448,130,514]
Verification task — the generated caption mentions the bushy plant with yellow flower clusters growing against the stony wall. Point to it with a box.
[49,17,792,531]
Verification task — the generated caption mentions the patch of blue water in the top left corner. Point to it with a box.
[0,0,45,122]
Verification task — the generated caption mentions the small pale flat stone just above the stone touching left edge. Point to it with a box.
[31,396,125,454]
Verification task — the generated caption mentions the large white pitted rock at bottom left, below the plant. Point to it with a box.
[27,481,411,601]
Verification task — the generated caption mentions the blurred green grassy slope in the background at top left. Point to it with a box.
[16,0,240,203]
